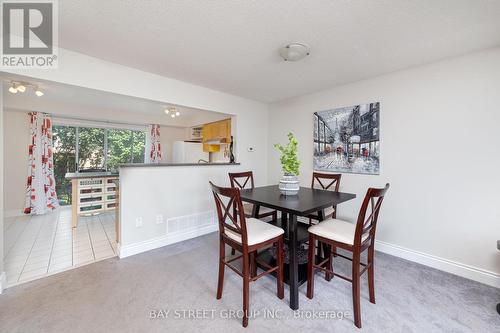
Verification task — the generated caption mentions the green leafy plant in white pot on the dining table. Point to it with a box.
[274,133,300,195]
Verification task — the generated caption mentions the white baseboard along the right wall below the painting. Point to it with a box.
[375,241,500,288]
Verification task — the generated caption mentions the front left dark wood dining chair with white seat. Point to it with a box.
[210,182,284,327]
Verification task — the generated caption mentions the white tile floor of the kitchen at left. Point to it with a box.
[4,207,116,287]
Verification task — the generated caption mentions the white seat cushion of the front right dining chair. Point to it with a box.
[307,219,369,245]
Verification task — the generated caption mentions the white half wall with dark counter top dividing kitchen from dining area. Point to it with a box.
[119,163,240,258]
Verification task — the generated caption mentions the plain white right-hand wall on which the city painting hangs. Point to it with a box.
[268,48,500,287]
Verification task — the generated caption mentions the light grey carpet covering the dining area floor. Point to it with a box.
[0,234,500,333]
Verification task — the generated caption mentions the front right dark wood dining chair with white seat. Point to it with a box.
[307,184,389,328]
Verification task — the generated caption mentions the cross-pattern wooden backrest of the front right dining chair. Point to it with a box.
[354,183,390,245]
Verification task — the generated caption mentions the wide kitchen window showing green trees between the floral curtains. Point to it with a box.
[53,125,146,205]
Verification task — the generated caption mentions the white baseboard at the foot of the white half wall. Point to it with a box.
[118,224,219,259]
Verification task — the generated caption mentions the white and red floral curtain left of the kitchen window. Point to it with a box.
[24,112,59,215]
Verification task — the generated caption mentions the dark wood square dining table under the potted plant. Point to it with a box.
[240,185,356,310]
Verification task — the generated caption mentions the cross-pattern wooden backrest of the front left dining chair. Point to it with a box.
[209,182,248,244]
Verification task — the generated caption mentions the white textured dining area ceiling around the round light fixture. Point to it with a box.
[59,0,500,102]
